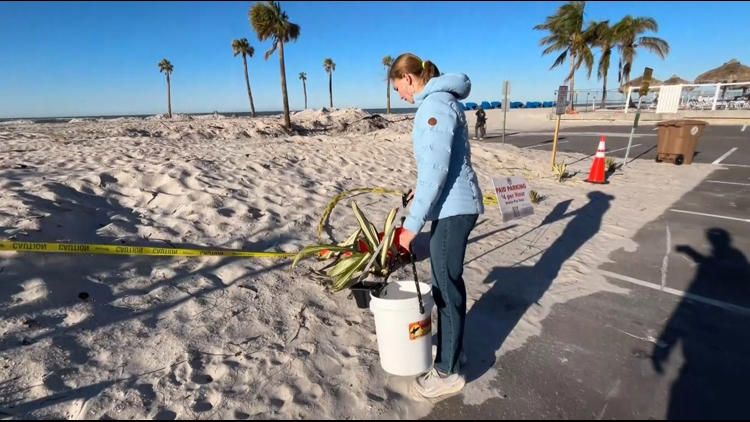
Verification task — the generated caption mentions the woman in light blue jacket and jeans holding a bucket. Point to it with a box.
[388,53,484,398]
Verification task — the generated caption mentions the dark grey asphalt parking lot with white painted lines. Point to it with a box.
[426,125,750,420]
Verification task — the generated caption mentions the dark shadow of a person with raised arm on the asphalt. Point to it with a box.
[651,228,750,419]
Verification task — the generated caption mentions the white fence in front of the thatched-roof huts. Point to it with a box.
[624,81,750,113]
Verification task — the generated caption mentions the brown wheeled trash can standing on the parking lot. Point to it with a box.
[656,120,708,165]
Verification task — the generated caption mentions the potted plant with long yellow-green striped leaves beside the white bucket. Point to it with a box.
[290,201,403,292]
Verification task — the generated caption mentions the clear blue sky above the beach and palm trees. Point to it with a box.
[0,2,750,118]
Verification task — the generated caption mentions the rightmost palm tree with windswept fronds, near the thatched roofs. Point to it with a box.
[613,15,669,86]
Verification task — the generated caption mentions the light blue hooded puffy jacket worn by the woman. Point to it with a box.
[404,73,484,233]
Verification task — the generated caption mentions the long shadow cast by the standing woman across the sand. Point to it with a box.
[463,191,614,381]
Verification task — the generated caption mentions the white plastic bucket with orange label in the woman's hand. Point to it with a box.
[370,280,434,376]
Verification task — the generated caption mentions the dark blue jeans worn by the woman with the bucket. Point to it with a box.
[430,214,479,374]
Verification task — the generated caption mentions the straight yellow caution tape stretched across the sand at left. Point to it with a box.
[0,240,297,258]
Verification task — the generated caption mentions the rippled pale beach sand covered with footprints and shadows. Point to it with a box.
[0,109,711,419]
